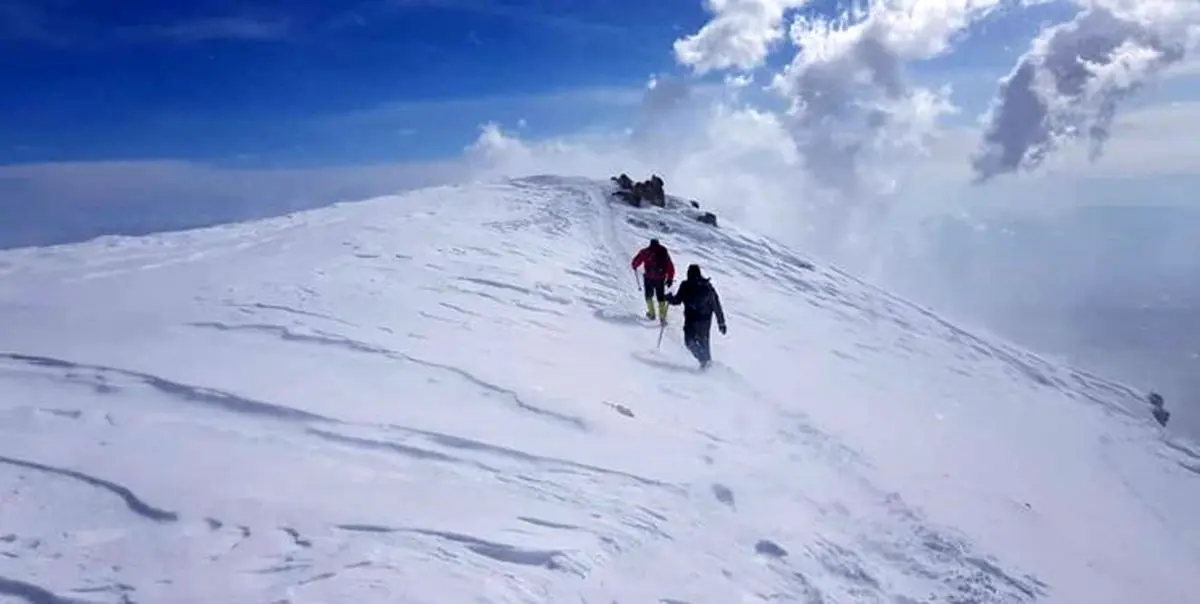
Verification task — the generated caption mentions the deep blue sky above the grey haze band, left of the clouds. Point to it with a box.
[0,0,706,165]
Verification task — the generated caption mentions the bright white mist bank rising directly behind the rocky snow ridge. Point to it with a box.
[446,84,1200,298]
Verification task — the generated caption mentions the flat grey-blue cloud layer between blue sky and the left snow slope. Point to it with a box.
[0,161,466,249]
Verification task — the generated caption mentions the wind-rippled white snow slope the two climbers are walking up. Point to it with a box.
[0,177,1200,604]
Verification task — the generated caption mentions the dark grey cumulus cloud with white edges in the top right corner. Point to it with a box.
[972,0,1200,183]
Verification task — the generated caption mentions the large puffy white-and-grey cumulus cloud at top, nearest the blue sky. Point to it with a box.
[676,0,1001,199]
